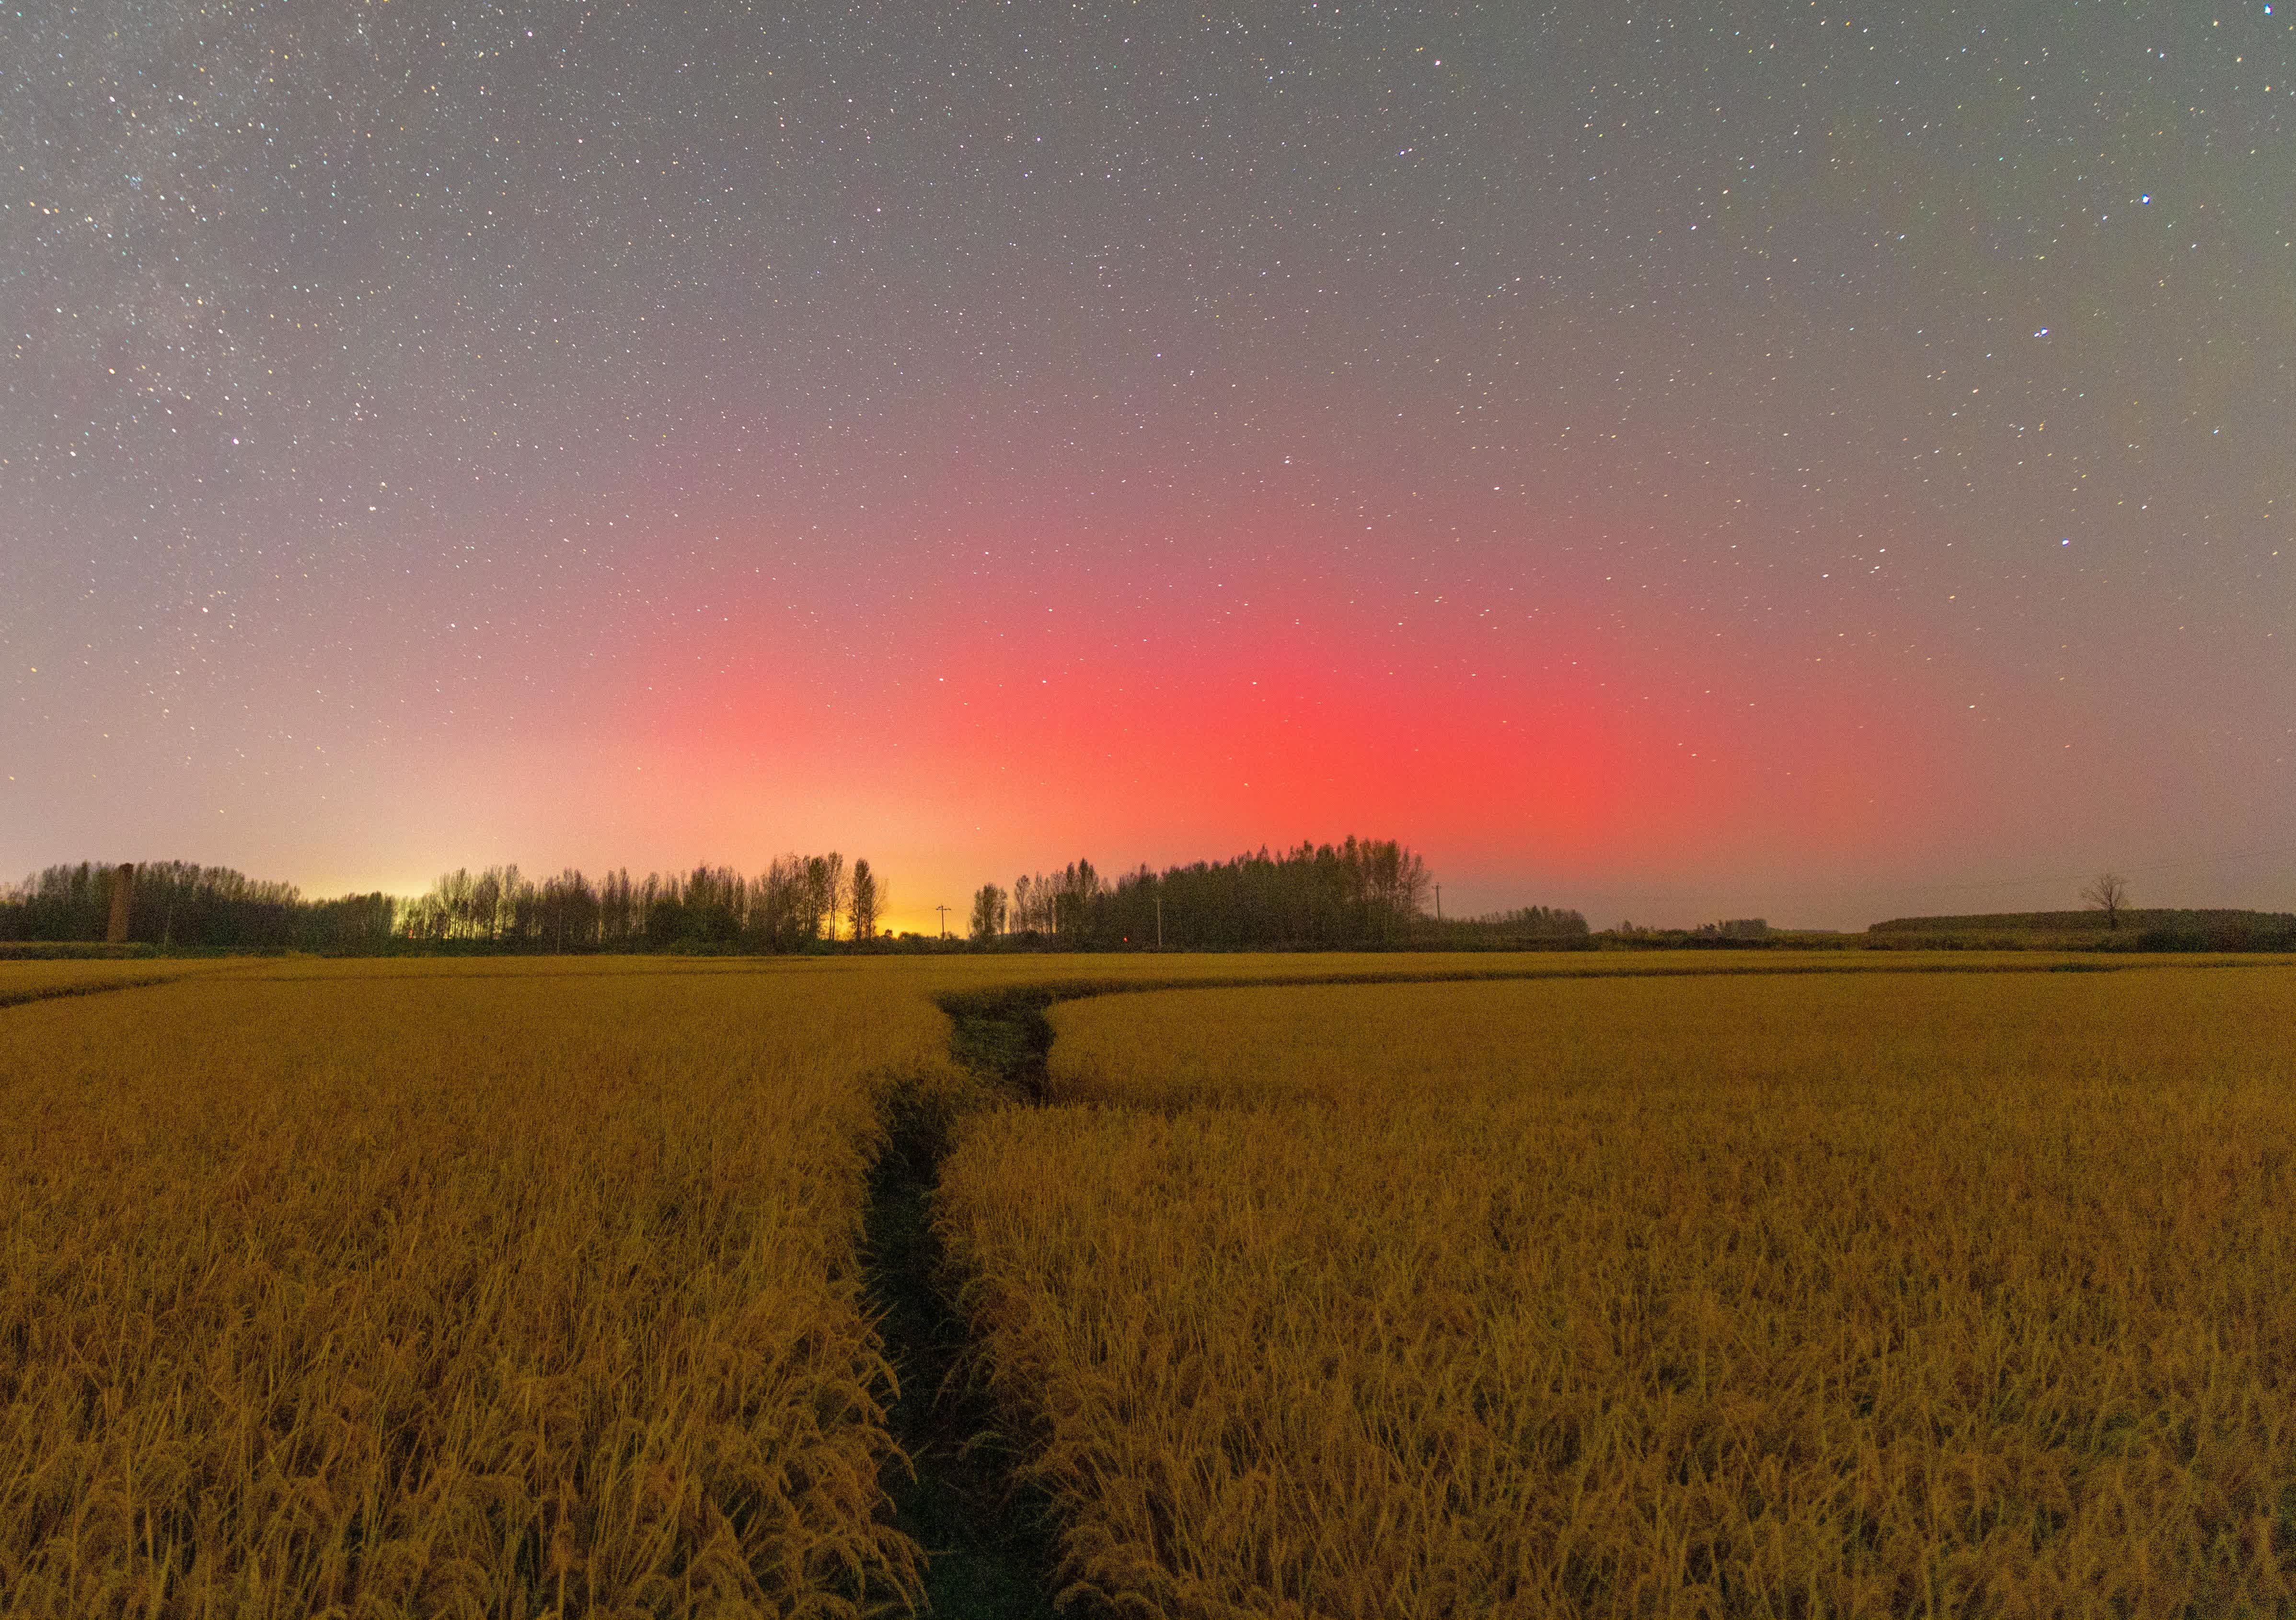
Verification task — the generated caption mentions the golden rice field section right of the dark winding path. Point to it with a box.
[939,958,2296,1620]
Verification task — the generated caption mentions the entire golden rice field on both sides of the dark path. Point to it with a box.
[0,951,2296,1620]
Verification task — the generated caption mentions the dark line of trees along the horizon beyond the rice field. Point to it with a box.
[0,836,1589,954]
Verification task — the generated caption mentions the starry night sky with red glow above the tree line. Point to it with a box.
[0,0,2296,926]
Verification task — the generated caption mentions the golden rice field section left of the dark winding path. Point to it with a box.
[0,960,946,1615]
